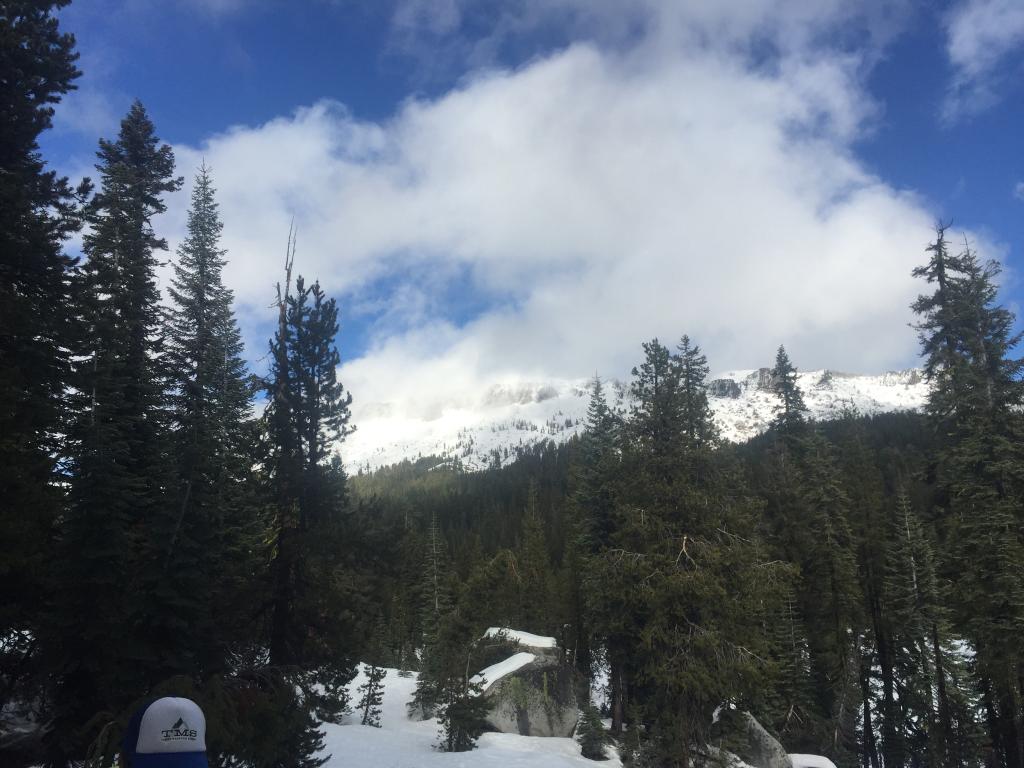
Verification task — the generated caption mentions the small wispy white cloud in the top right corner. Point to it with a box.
[943,0,1024,121]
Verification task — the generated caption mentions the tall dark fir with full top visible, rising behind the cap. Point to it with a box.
[48,101,183,757]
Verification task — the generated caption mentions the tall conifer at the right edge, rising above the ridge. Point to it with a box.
[913,227,1024,768]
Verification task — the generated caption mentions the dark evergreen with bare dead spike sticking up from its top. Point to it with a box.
[265,246,355,675]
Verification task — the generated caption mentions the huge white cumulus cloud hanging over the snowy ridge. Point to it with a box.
[163,0,946,428]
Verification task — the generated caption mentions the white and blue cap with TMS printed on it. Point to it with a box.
[122,696,209,768]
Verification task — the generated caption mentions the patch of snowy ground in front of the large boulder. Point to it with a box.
[323,667,622,768]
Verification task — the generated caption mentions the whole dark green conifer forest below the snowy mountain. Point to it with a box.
[0,0,1024,768]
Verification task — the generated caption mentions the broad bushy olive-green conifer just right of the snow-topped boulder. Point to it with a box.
[591,342,781,765]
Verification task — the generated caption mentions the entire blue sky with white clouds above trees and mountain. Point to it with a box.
[41,0,1024,421]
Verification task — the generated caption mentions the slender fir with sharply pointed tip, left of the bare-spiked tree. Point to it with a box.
[160,165,261,673]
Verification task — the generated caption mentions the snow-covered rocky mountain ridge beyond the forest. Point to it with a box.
[341,368,928,472]
